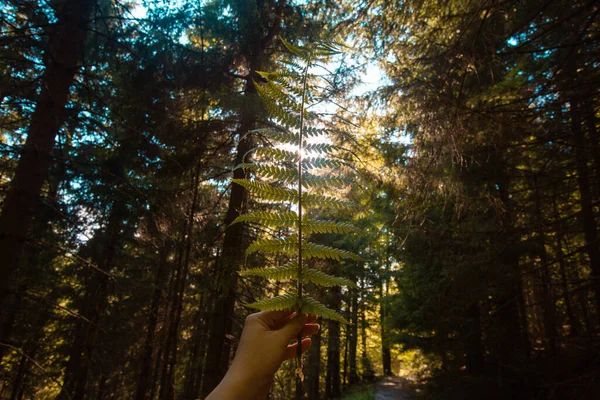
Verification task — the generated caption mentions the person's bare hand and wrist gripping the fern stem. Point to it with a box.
[206,311,319,400]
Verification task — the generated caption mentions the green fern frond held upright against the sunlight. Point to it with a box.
[233,40,361,323]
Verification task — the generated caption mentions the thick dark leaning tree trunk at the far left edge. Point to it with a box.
[0,0,94,308]
